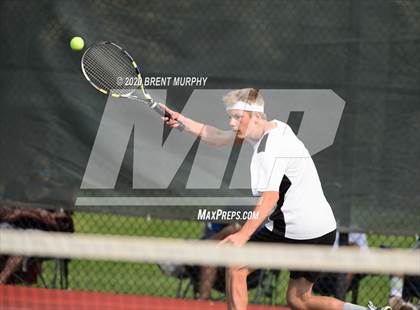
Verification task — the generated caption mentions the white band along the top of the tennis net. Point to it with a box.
[0,230,420,274]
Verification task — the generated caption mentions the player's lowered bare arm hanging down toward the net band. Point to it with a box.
[221,192,279,246]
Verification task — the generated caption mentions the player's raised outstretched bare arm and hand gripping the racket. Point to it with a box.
[161,104,235,146]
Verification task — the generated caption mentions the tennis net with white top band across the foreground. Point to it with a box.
[0,230,420,310]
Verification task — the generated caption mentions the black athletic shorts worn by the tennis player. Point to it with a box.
[249,226,336,283]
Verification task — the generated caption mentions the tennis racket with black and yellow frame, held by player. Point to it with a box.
[82,41,185,130]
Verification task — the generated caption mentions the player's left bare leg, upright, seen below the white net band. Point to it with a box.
[226,267,249,310]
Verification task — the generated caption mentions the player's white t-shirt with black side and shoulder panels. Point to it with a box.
[251,120,337,240]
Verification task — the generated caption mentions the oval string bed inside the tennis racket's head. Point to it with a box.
[83,44,137,95]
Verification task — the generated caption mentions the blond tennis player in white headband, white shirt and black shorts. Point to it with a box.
[162,88,390,310]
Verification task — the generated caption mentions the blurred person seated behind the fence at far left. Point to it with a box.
[0,156,74,284]
